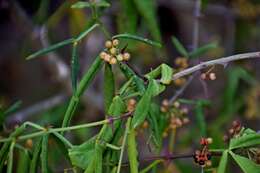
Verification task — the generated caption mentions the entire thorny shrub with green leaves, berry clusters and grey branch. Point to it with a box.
[0,1,260,173]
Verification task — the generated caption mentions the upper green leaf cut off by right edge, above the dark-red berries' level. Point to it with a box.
[229,133,260,149]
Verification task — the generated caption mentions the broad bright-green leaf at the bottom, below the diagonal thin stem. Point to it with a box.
[69,136,96,169]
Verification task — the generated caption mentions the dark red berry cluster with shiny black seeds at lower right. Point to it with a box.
[193,138,212,167]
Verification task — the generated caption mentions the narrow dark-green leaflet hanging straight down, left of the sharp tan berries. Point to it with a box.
[71,42,79,93]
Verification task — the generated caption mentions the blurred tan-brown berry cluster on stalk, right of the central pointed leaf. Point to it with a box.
[161,99,190,137]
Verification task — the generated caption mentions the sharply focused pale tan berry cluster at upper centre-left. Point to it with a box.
[100,39,130,65]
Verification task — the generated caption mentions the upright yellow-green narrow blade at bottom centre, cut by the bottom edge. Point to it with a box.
[127,125,138,173]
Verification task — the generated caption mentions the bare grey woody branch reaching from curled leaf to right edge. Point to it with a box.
[172,52,260,80]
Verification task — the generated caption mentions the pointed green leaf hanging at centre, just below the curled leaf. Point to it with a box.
[131,79,165,128]
